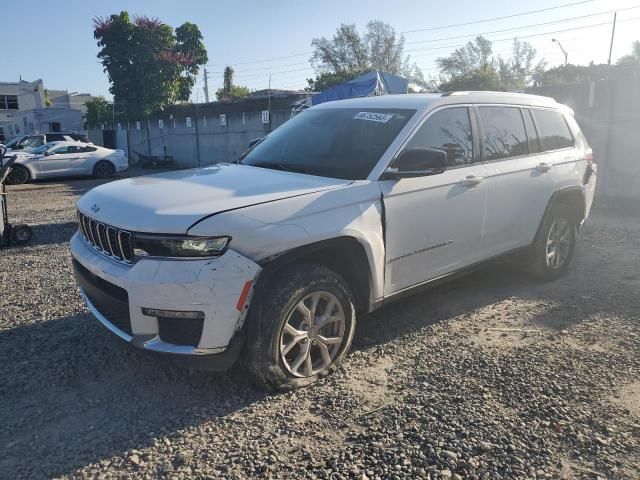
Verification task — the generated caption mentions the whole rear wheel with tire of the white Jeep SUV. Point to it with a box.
[529,204,577,281]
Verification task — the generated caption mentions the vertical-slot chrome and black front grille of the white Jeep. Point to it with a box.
[77,212,133,263]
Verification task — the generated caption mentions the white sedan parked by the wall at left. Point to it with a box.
[7,142,129,185]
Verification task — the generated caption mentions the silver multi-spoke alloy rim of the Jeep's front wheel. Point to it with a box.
[279,291,346,377]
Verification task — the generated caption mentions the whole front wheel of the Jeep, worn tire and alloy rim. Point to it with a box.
[247,264,356,391]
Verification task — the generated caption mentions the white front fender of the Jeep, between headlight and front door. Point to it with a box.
[189,181,385,299]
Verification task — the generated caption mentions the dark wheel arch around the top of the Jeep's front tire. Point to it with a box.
[254,236,373,311]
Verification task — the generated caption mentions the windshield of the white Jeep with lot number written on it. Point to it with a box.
[242,108,416,180]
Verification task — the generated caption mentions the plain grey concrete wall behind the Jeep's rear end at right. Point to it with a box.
[527,77,640,200]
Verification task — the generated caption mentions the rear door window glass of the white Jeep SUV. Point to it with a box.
[478,107,529,161]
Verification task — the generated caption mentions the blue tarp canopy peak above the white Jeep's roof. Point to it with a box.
[311,71,409,105]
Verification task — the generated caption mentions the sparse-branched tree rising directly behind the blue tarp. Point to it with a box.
[307,20,424,91]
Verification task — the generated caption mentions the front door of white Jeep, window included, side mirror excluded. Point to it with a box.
[380,106,487,295]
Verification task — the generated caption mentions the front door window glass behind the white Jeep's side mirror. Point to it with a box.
[407,107,473,167]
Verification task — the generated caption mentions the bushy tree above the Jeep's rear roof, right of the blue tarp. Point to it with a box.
[436,35,546,90]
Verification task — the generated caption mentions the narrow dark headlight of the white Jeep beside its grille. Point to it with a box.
[133,235,231,258]
